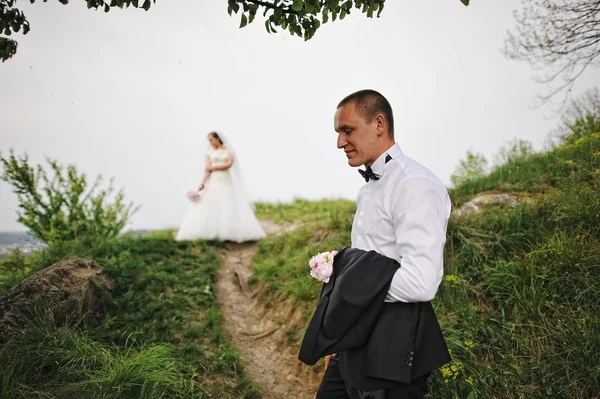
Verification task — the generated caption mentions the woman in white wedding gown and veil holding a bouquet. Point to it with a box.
[175,132,266,242]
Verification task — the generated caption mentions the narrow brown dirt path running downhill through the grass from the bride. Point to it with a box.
[216,221,320,399]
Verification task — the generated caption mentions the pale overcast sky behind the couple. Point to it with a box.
[0,0,598,231]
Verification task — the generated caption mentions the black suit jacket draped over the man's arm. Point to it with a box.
[298,248,450,390]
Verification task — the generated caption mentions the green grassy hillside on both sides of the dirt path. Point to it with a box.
[0,121,600,399]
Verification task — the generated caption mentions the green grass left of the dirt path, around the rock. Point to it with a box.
[0,234,261,399]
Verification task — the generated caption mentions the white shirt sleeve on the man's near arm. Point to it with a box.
[386,177,450,302]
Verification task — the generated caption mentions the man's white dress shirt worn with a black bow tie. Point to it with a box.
[351,144,451,302]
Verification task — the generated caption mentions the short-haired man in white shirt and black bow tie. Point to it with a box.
[317,90,451,399]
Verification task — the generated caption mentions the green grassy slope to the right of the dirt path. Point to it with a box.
[251,131,600,399]
